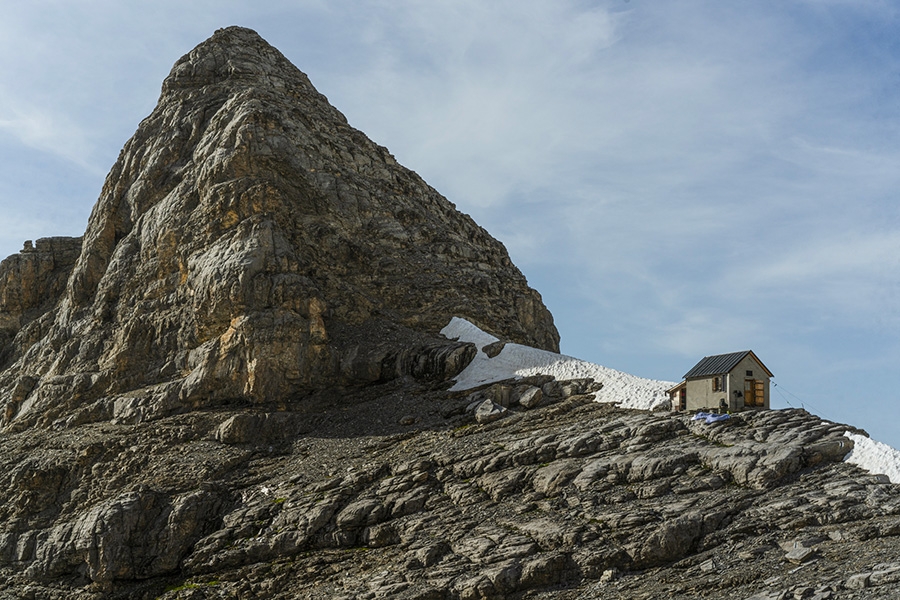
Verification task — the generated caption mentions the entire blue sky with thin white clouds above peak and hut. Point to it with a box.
[0,0,900,447]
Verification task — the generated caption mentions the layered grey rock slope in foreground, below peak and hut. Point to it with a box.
[0,380,900,600]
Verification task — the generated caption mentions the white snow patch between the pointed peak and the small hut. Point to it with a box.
[441,317,675,410]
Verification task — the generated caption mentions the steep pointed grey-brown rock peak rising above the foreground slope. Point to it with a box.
[0,27,559,428]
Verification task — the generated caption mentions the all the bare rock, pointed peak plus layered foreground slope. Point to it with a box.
[0,28,900,600]
